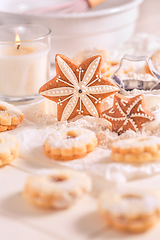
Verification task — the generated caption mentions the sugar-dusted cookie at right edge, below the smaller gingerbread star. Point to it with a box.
[111,136,160,163]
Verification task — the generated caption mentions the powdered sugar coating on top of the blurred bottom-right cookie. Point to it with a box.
[99,188,160,218]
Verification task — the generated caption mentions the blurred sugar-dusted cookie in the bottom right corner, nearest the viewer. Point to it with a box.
[99,188,160,233]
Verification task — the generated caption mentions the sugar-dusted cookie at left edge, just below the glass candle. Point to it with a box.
[0,101,24,132]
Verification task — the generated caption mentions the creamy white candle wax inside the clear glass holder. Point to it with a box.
[0,42,49,97]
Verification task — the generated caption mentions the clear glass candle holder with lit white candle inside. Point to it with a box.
[0,24,51,102]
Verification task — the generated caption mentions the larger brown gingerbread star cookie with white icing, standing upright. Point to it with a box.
[39,54,119,121]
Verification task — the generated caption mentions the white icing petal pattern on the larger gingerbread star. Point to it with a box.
[41,56,118,121]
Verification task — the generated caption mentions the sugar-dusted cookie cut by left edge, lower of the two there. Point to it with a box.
[0,133,19,166]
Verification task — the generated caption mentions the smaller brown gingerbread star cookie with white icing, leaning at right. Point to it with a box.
[101,93,154,134]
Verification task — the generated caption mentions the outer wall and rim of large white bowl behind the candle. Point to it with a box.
[0,0,143,62]
